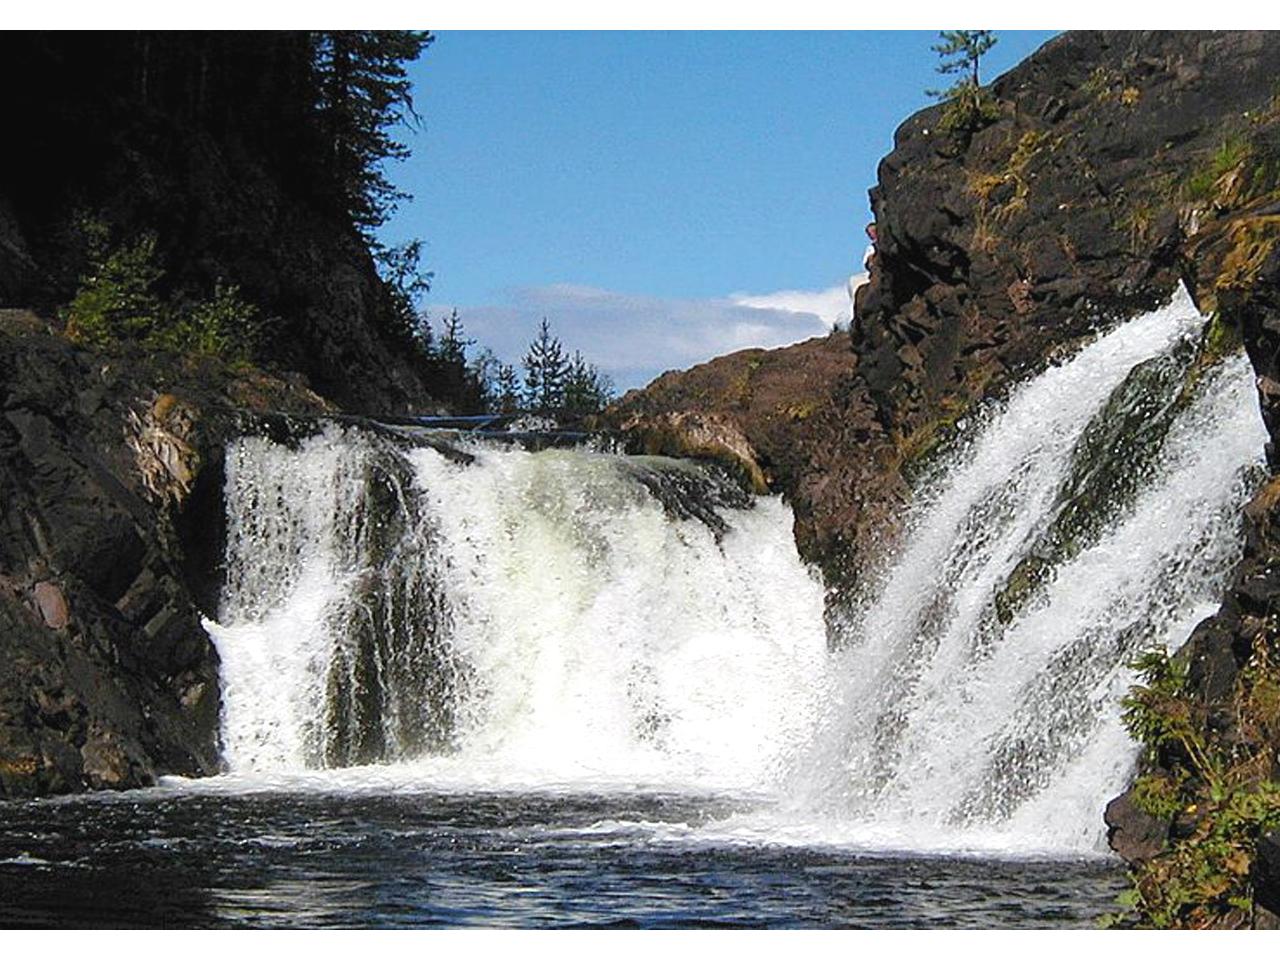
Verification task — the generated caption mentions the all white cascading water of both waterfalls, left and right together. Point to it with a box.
[207,284,1266,855]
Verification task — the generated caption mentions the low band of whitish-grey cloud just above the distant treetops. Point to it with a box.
[431,273,870,389]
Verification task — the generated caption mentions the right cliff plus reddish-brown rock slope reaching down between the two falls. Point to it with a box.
[611,32,1280,586]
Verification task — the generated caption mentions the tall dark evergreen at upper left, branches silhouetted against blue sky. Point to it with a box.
[312,31,434,240]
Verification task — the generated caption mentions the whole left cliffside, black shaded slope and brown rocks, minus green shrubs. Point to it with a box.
[0,32,450,797]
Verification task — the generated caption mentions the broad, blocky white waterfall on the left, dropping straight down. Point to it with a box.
[207,440,827,788]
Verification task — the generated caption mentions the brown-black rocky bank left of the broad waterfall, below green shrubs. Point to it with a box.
[0,311,335,796]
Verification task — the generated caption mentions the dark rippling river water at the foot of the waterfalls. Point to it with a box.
[0,790,1123,928]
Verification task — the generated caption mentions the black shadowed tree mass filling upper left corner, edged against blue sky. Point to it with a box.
[0,31,462,406]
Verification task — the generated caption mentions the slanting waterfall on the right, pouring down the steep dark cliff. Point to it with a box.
[791,291,1266,852]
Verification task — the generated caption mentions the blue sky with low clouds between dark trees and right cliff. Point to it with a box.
[384,32,1052,388]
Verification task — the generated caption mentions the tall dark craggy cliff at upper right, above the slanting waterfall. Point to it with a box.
[854,32,1280,435]
